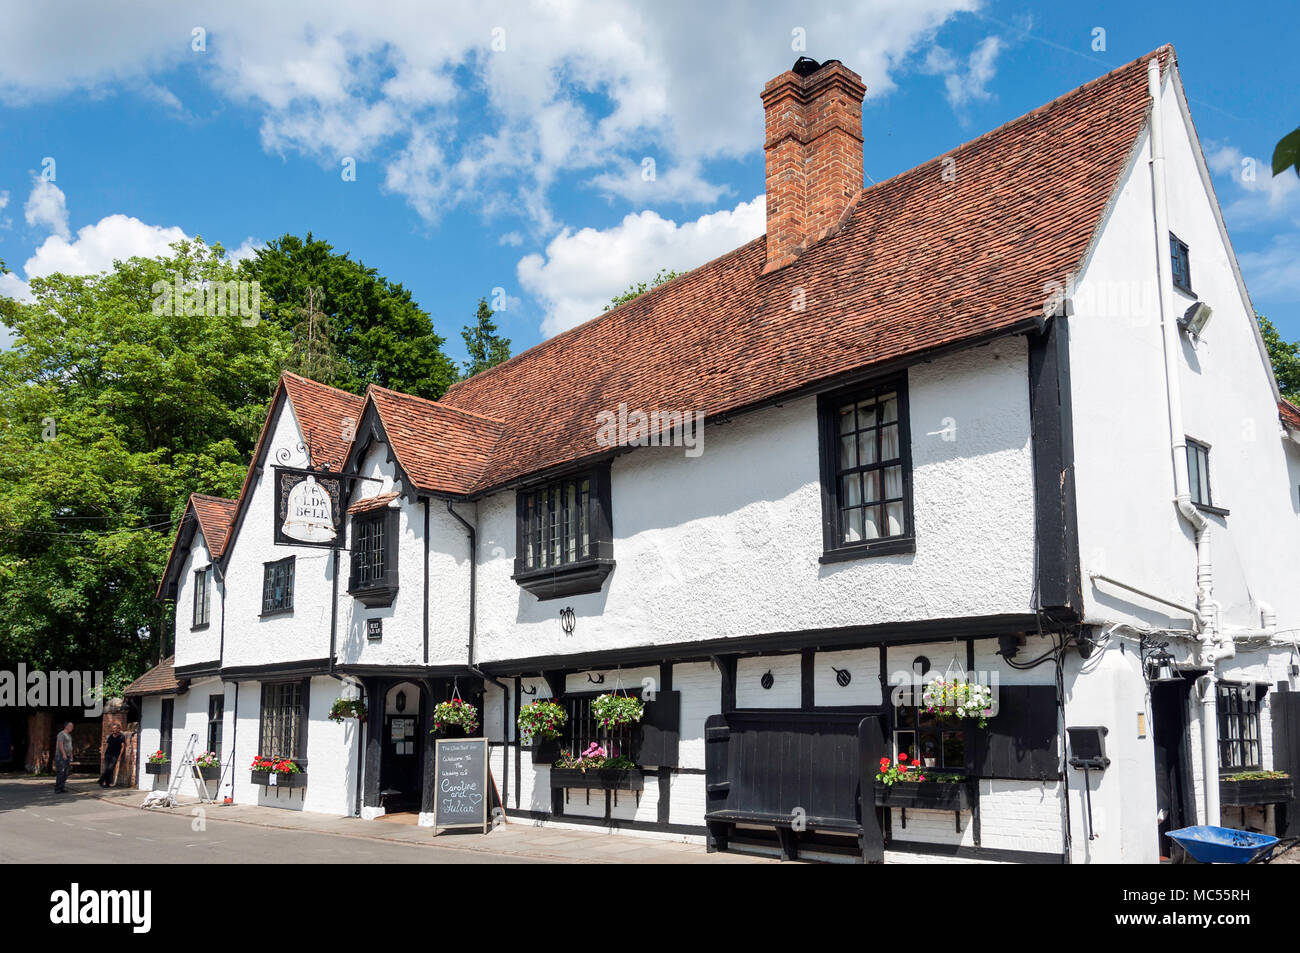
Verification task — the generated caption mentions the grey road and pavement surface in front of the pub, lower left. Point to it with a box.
[0,775,776,863]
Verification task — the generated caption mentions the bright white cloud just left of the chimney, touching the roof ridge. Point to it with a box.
[517,195,767,337]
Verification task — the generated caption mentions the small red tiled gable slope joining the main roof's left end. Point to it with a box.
[367,386,504,495]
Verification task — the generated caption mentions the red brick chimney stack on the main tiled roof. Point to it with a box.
[763,56,867,274]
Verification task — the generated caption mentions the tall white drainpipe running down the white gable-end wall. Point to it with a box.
[1147,59,1216,826]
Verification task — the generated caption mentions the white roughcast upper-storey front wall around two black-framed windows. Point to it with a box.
[477,338,1034,660]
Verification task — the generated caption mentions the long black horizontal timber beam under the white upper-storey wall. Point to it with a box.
[482,612,1039,675]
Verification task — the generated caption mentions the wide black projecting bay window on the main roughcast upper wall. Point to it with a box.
[514,467,614,599]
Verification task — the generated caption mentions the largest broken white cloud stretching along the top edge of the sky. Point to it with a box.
[0,0,977,224]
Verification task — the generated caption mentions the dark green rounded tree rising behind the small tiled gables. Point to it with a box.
[239,233,456,398]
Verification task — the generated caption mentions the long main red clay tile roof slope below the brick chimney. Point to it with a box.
[439,46,1174,490]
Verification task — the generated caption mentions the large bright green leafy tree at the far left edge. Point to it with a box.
[0,242,290,684]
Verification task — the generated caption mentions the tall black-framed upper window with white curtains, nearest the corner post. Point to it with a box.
[818,377,915,562]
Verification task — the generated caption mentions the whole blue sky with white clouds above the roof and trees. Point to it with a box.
[0,0,1300,359]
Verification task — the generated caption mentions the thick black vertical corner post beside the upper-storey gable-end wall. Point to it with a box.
[1028,308,1083,621]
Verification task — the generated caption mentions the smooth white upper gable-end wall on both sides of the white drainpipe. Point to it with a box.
[1070,74,1300,639]
